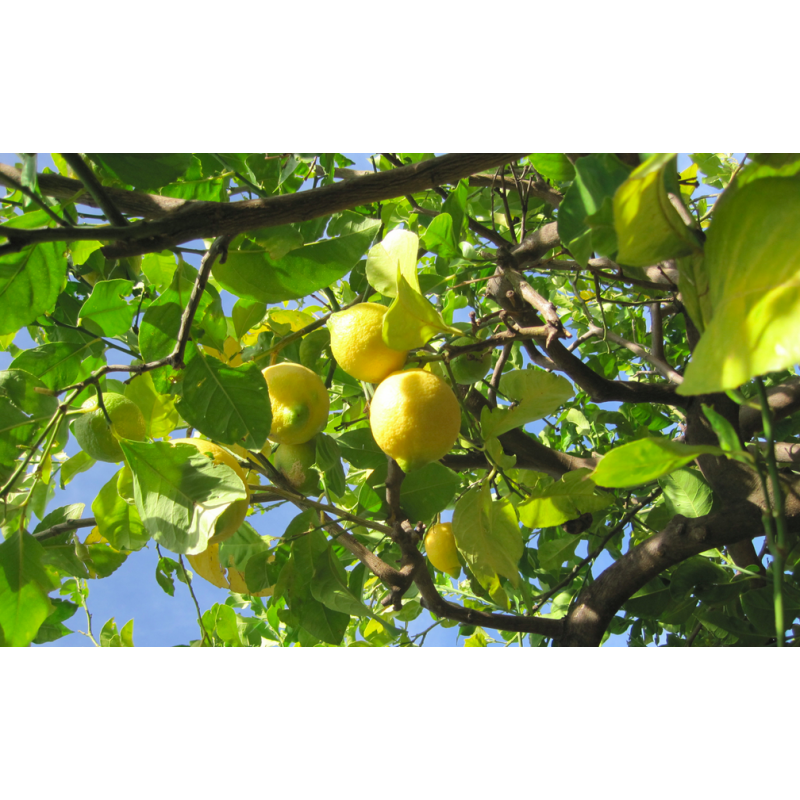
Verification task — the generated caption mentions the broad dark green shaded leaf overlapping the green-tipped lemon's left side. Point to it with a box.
[176,353,272,450]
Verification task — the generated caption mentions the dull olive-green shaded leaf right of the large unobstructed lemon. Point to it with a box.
[481,369,574,441]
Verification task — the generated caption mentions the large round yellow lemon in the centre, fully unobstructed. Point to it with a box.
[369,369,461,472]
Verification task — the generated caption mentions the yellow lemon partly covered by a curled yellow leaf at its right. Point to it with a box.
[328,303,406,383]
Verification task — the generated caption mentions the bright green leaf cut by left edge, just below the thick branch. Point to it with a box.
[0,242,67,335]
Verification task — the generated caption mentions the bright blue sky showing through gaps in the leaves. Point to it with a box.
[0,153,744,647]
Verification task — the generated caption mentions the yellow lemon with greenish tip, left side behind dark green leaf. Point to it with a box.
[263,361,330,444]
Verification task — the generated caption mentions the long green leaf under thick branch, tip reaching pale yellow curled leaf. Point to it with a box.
[213,220,380,303]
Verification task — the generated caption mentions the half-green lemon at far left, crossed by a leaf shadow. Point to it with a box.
[72,392,147,463]
